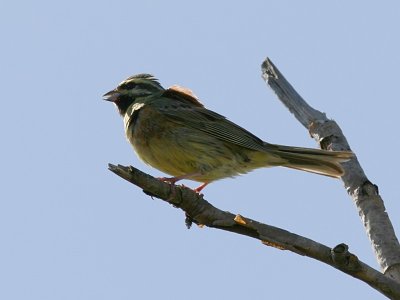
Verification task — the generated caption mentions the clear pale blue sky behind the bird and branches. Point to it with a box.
[0,1,400,300]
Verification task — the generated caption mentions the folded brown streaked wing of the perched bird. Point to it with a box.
[157,89,269,151]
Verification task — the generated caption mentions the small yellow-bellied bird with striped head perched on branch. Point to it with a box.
[103,73,353,193]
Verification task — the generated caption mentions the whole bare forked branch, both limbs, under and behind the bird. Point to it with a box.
[109,58,400,299]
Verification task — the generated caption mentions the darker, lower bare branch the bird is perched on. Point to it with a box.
[109,164,400,299]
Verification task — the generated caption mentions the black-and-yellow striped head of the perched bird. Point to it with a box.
[103,74,164,116]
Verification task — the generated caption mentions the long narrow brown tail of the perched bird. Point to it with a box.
[266,144,354,178]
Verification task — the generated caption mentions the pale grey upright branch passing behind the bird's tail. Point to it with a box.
[262,58,400,282]
